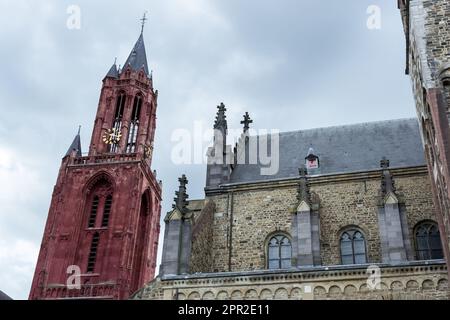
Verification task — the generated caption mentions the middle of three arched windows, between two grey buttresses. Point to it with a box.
[340,229,367,264]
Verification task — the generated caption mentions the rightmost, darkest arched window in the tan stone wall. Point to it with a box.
[414,221,444,260]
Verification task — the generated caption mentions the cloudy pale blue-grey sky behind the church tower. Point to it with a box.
[0,0,415,299]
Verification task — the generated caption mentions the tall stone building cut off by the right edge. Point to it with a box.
[398,0,450,276]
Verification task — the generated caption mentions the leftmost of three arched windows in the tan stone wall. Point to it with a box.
[267,234,292,269]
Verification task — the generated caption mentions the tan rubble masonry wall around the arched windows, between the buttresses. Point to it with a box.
[209,170,436,272]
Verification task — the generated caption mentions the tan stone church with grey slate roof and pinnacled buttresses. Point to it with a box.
[132,110,448,300]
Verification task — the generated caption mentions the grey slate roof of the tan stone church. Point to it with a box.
[230,119,425,183]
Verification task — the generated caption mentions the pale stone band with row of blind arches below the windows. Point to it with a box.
[132,262,449,300]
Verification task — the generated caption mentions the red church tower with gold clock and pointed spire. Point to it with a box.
[29,17,161,299]
